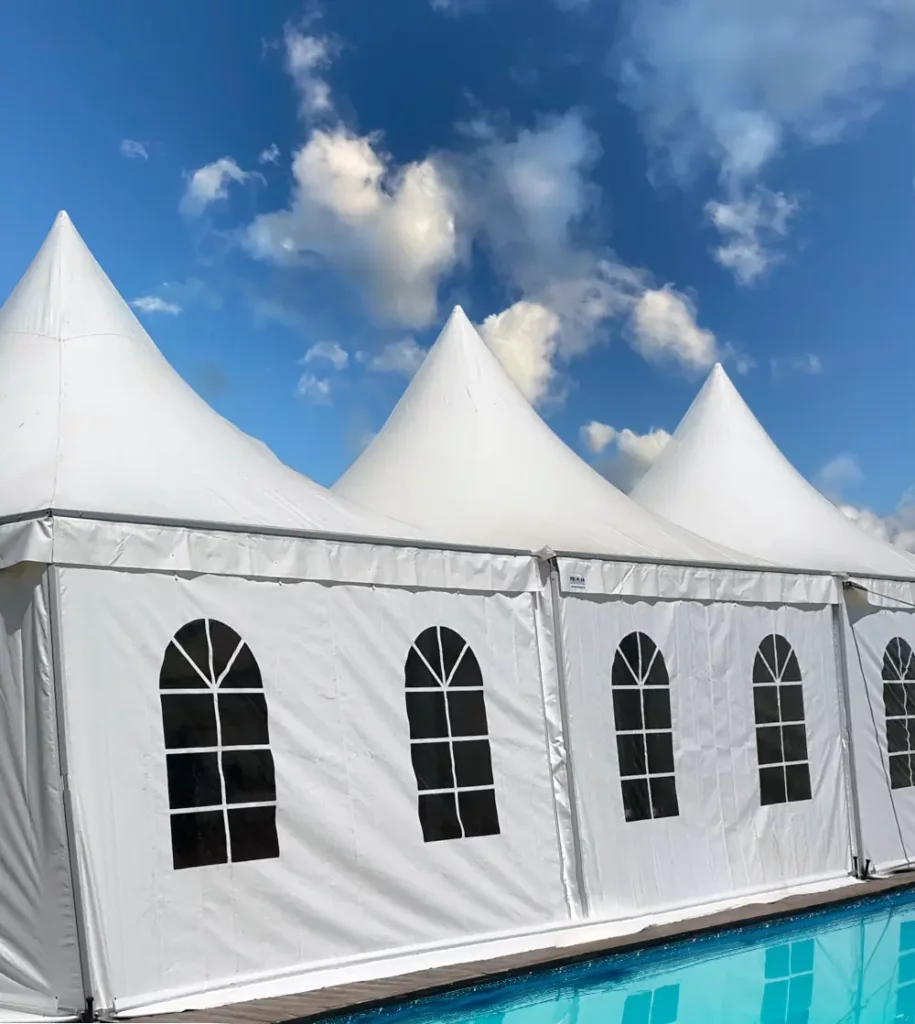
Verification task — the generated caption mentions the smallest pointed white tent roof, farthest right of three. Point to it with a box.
[633,365,915,578]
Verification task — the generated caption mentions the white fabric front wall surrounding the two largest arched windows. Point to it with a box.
[53,568,569,1012]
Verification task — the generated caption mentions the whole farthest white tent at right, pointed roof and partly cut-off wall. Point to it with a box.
[633,366,915,868]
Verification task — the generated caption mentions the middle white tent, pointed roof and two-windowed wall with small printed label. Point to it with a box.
[334,308,849,918]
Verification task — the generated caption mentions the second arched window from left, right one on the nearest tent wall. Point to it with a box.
[403,626,498,843]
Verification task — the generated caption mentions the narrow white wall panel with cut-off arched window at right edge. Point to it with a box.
[843,581,915,871]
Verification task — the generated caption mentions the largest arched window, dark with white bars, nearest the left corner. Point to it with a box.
[159,618,279,868]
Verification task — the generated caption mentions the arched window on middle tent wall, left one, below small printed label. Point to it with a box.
[611,633,680,821]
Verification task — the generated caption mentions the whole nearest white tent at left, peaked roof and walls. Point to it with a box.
[0,214,570,1020]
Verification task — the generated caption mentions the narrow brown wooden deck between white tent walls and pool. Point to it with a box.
[134,871,915,1024]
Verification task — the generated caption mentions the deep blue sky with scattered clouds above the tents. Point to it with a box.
[0,0,915,532]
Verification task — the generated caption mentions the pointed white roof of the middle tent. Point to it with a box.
[333,306,761,562]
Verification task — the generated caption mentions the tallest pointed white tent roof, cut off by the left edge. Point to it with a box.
[0,211,416,537]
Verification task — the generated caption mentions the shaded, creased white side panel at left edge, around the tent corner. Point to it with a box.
[0,564,84,1020]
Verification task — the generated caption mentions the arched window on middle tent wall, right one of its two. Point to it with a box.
[753,633,811,804]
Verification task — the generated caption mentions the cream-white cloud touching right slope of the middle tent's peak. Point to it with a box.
[480,300,560,402]
